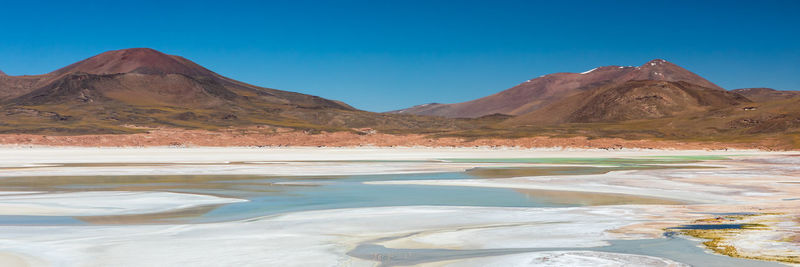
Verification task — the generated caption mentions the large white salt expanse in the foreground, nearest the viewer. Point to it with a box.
[0,206,668,266]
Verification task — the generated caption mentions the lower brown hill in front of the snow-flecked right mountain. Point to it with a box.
[504,80,751,125]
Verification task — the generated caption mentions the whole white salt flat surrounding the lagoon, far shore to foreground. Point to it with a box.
[0,147,800,266]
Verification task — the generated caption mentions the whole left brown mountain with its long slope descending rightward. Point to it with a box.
[0,48,467,134]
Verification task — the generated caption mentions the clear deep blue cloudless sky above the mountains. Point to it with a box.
[0,0,800,111]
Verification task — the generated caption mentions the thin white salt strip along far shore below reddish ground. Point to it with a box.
[0,146,788,168]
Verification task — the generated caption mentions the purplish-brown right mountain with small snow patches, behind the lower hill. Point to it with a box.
[392,59,723,118]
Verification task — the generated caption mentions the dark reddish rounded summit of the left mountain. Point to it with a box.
[54,48,212,76]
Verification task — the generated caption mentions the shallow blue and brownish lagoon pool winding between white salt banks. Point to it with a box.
[0,173,608,225]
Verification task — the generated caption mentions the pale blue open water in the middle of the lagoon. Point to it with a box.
[196,173,577,222]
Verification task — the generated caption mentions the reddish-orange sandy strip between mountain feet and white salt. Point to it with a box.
[0,127,792,150]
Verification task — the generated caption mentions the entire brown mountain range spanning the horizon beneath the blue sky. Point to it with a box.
[0,48,800,148]
